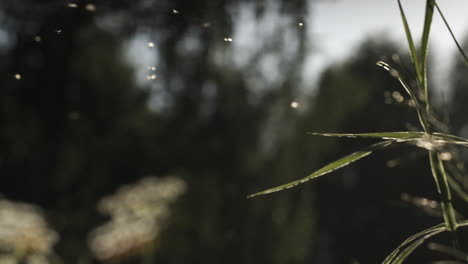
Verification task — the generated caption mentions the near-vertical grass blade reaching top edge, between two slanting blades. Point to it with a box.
[421,0,435,109]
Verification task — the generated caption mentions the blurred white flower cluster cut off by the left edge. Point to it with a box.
[0,200,58,263]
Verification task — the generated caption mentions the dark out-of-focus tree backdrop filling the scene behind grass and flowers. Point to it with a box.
[0,0,468,264]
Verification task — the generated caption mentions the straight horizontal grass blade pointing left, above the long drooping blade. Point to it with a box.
[307,131,425,141]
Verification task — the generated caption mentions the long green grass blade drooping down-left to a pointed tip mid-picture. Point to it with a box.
[247,140,393,198]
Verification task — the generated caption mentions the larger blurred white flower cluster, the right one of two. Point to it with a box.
[90,176,186,260]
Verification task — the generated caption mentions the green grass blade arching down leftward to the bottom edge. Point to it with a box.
[382,224,446,264]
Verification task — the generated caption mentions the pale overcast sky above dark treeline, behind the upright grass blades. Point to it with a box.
[308,0,468,88]
